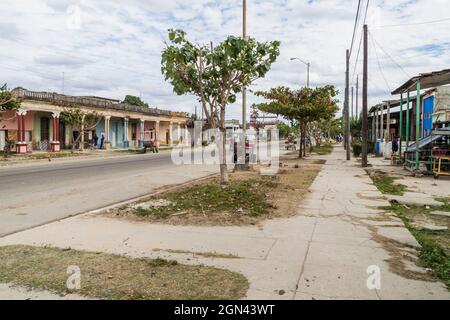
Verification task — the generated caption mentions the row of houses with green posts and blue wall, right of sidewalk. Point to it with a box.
[369,69,450,172]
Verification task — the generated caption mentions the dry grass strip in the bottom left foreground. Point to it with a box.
[0,246,248,300]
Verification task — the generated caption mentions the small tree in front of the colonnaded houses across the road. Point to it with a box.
[60,108,101,153]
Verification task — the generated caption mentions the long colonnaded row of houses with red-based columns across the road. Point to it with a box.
[0,88,188,153]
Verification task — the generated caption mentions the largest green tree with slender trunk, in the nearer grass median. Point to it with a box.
[161,29,280,184]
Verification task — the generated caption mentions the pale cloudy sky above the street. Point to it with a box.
[0,0,450,119]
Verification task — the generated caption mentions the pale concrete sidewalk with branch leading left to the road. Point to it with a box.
[0,147,450,299]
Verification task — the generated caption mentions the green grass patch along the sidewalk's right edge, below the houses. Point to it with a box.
[388,199,450,290]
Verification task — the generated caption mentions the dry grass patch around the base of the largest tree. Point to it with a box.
[103,158,321,226]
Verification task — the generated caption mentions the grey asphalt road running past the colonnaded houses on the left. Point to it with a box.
[0,152,218,236]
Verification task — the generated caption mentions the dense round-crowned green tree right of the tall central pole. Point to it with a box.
[255,85,339,158]
